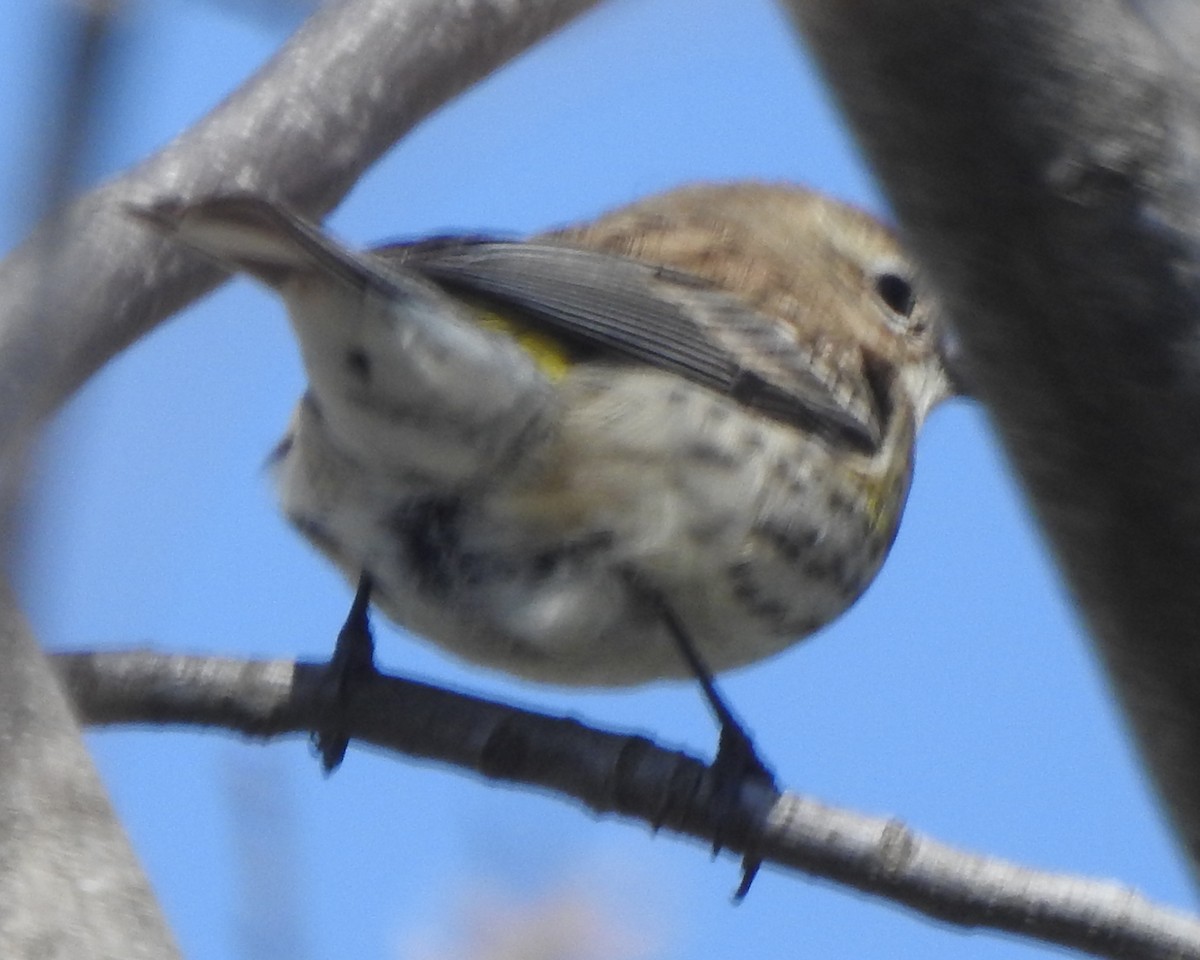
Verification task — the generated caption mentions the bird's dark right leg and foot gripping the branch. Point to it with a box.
[643,587,775,901]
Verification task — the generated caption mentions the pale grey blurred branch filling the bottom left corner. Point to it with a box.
[0,583,179,960]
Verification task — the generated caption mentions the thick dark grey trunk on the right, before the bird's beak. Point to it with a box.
[788,0,1200,883]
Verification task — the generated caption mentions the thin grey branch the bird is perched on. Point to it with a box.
[53,650,1200,960]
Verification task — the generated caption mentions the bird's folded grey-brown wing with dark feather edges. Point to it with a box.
[371,238,881,452]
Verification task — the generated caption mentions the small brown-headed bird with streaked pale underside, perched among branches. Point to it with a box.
[137,182,953,892]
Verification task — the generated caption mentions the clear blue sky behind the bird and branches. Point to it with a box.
[0,0,1192,960]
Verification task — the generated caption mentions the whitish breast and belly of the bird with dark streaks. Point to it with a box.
[272,366,907,685]
